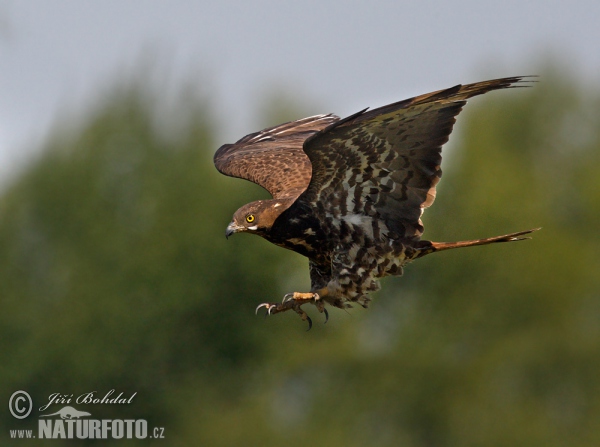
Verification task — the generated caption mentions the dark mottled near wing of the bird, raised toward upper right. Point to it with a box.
[301,77,524,238]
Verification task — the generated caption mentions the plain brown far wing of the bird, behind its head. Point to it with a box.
[214,114,339,199]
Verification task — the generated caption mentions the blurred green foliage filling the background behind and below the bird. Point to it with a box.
[0,68,600,446]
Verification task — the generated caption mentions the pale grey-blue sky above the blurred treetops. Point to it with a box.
[0,0,600,184]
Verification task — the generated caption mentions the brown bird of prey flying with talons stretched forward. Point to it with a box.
[214,76,537,329]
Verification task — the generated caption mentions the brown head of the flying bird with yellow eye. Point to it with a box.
[225,199,289,237]
